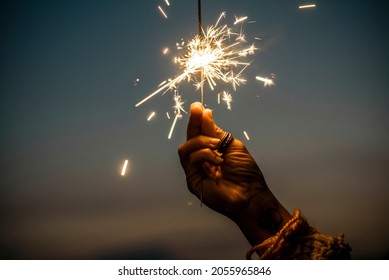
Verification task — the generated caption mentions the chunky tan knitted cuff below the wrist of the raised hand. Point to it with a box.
[246,209,351,260]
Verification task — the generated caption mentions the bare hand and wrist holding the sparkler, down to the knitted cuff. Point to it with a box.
[178,103,291,244]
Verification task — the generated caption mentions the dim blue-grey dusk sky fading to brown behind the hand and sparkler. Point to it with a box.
[0,0,389,259]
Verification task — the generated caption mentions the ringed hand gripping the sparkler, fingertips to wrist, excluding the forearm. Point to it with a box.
[178,103,268,218]
